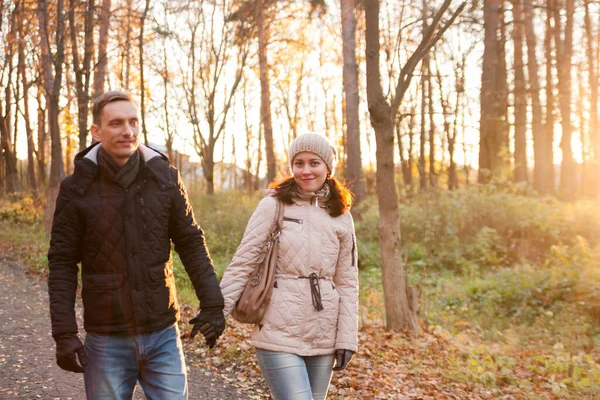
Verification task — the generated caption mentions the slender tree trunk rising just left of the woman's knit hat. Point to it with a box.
[256,0,277,182]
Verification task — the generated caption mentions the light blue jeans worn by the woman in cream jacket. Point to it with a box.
[256,349,334,400]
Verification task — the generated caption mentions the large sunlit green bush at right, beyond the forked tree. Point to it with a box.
[400,186,600,272]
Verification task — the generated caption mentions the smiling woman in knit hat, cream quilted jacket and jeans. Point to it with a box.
[221,133,358,400]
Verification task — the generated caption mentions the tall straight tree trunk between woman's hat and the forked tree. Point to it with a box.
[340,0,366,203]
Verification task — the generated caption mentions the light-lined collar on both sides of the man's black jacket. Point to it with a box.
[72,143,175,195]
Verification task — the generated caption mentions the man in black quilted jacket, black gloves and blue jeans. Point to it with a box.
[48,91,225,399]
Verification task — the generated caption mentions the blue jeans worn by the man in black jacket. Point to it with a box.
[84,324,188,400]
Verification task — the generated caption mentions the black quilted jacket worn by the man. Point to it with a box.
[48,145,223,335]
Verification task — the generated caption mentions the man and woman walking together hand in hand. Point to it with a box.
[48,91,358,400]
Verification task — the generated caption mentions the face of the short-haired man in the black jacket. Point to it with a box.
[91,100,140,165]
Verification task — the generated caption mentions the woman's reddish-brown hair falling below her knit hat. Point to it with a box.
[269,176,354,217]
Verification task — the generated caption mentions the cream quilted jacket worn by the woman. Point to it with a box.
[221,197,358,356]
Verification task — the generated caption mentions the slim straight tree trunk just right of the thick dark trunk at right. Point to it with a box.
[512,0,528,182]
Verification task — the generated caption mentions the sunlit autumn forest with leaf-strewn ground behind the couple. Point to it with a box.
[0,0,600,399]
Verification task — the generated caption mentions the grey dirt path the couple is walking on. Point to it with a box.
[0,254,250,400]
